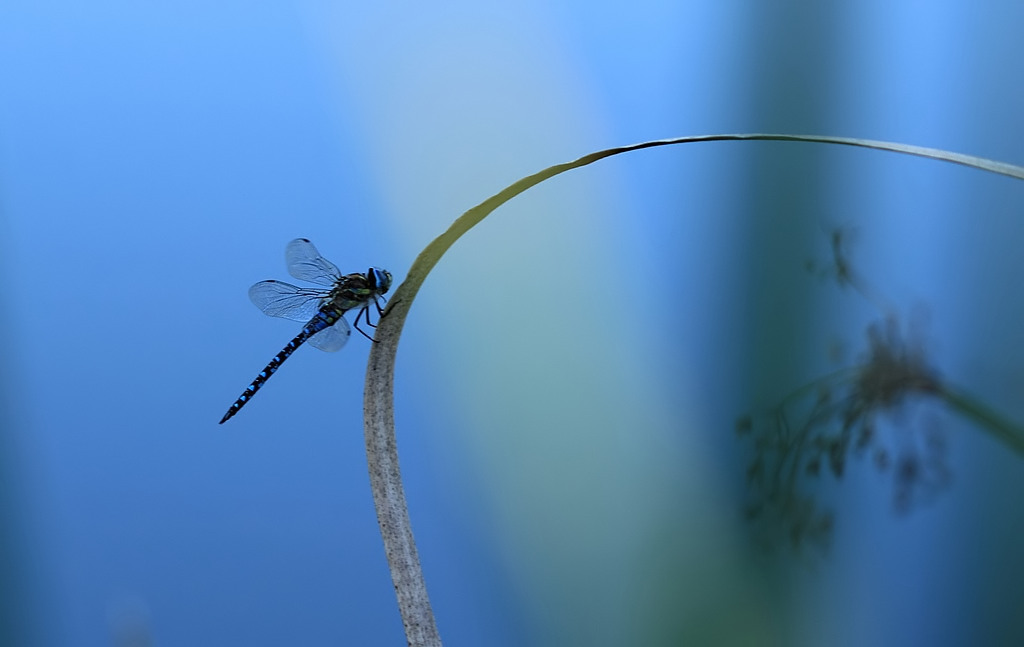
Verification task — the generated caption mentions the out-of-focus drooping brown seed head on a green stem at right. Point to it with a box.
[736,229,1024,549]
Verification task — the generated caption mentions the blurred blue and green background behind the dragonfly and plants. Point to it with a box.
[0,0,1024,647]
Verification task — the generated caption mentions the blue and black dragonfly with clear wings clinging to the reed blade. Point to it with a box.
[220,239,391,425]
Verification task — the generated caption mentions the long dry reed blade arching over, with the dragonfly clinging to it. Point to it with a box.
[364,133,1024,646]
